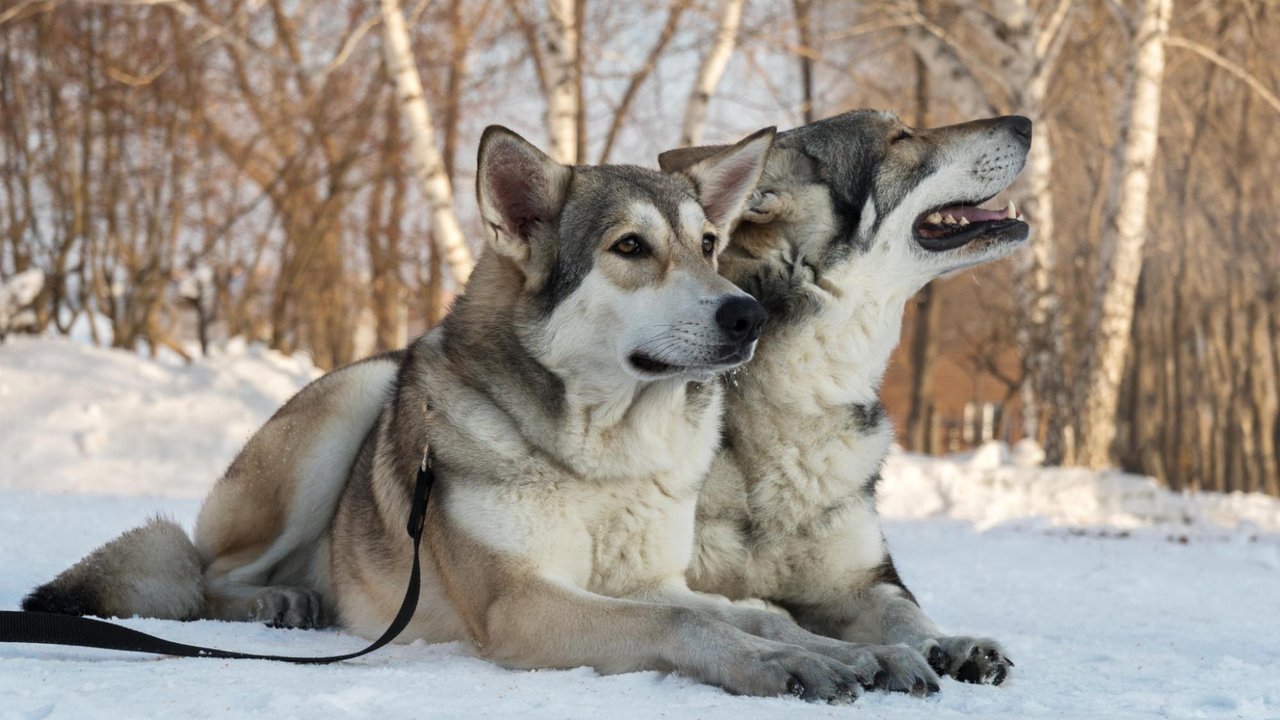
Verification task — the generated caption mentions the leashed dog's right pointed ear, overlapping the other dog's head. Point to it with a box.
[681,128,776,228]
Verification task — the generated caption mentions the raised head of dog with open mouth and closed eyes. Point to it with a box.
[659,110,1032,311]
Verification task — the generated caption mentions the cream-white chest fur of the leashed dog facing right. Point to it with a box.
[448,382,722,596]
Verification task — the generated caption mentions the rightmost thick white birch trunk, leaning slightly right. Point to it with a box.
[1078,0,1172,468]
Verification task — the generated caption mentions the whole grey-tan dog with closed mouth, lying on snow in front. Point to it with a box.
[23,128,929,701]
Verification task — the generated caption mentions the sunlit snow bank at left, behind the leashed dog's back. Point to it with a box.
[0,337,316,498]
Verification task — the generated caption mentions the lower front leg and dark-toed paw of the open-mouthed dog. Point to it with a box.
[833,573,1014,685]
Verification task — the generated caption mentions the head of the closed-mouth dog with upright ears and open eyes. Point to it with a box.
[476,127,774,380]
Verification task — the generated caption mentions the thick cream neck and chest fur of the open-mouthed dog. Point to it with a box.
[694,263,905,597]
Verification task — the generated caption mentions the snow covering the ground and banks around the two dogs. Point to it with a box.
[0,340,1280,720]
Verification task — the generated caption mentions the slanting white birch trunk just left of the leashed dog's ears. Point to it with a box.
[381,0,475,284]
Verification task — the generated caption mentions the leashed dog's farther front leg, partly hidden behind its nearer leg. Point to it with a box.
[643,580,938,694]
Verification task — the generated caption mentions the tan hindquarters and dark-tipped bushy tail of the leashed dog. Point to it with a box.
[22,352,402,626]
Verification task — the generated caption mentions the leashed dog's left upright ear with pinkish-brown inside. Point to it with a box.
[476,126,572,268]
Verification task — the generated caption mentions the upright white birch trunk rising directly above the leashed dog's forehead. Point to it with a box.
[540,0,581,164]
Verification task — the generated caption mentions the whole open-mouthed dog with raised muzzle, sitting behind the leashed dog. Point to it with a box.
[659,110,1032,684]
